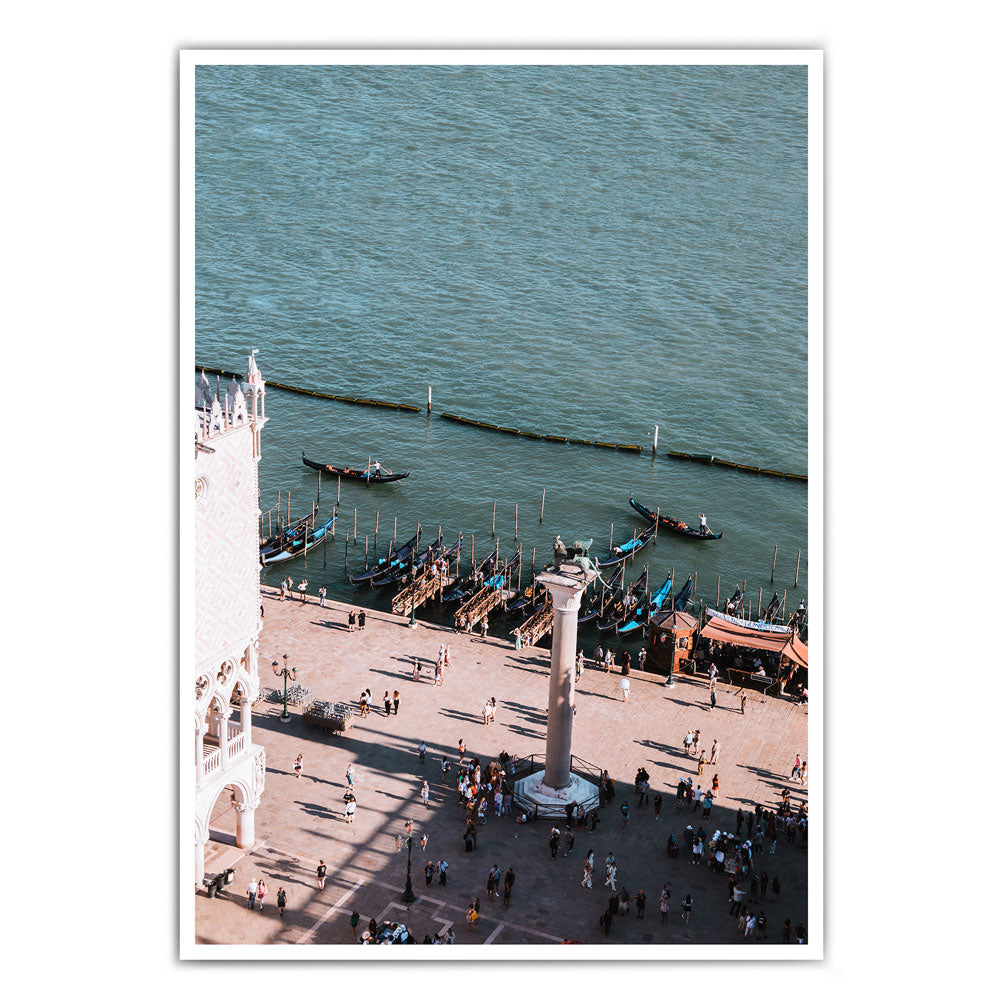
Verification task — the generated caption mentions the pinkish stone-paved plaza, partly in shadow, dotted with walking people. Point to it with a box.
[195,588,808,945]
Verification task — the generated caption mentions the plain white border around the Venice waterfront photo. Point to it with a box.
[184,49,825,962]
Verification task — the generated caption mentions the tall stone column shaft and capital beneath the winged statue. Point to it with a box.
[538,565,587,789]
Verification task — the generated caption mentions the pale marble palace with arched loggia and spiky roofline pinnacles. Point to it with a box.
[192,355,267,887]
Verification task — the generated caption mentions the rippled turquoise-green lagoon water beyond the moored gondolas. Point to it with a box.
[196,66,808,636]
